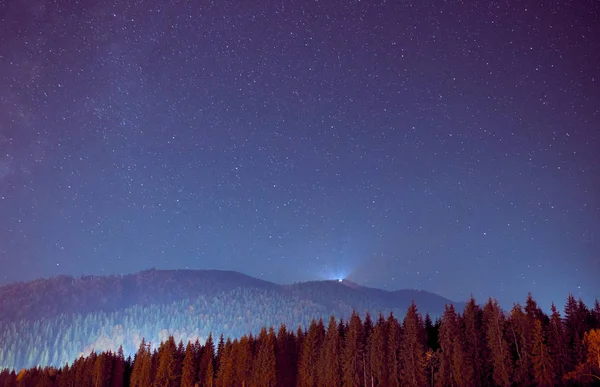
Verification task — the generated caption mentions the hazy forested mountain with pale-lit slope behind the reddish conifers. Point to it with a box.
[0,270,464,370]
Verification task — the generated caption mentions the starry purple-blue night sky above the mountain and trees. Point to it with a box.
[0,0,600,308]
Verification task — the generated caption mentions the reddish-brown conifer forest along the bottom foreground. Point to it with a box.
[0,295,600,387]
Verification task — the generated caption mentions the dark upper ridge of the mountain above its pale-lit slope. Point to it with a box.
[0,269,464,321]
